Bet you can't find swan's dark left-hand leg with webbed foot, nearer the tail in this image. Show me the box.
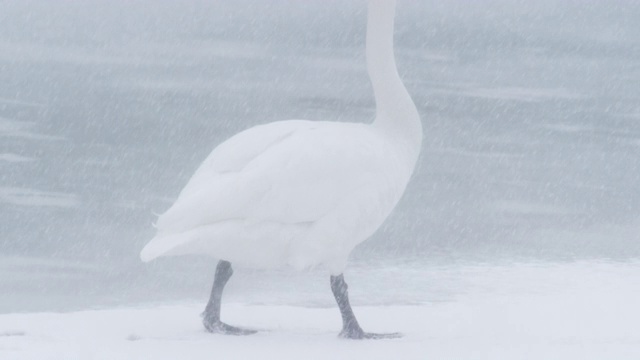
[202,260,257,335]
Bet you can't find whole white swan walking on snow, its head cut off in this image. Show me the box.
[140,0,422,339]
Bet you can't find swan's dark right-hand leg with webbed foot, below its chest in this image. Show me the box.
[331,274,402,339]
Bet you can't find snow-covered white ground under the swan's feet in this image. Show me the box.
[0,262,640,360]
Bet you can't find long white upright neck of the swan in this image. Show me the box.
[367,0,422,165]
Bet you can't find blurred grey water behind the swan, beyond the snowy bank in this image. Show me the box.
[0,0,640,312]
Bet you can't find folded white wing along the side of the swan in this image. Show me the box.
[157,121,394,233]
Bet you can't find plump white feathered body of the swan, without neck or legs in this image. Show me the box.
[142,121,411,274]
